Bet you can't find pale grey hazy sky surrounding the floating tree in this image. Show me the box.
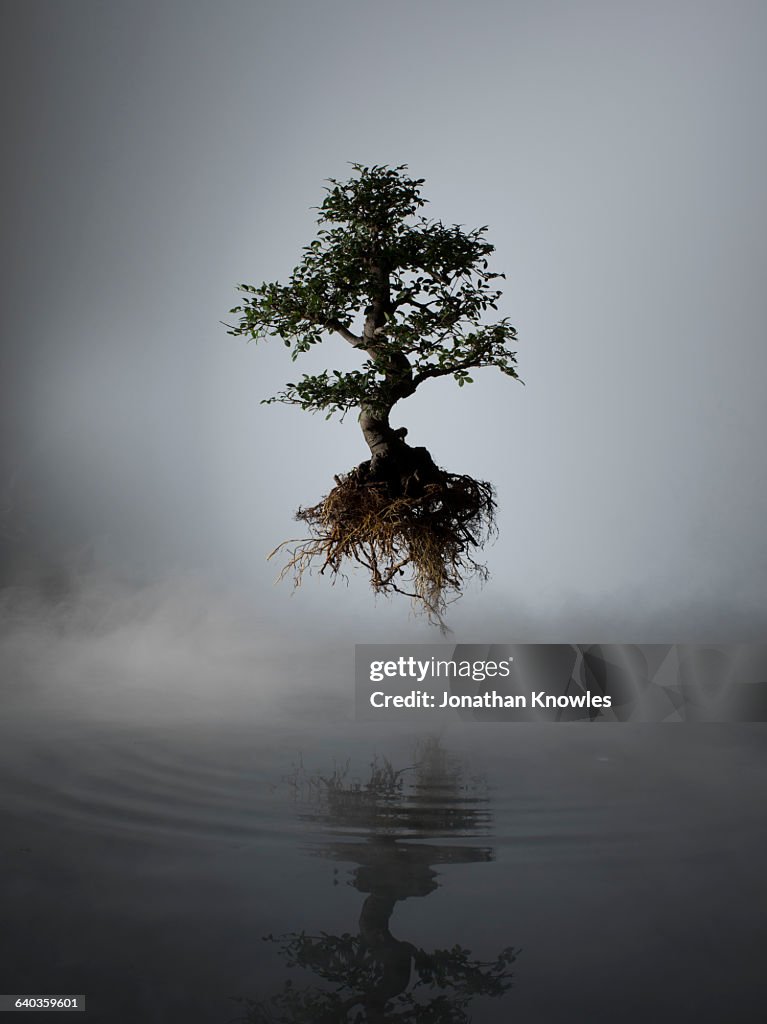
[0,0,767,641]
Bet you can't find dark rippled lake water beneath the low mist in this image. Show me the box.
[0,614,767,1024]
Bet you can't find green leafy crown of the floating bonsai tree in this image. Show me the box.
[224,164,517,415]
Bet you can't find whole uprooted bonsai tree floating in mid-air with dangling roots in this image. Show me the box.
[226,164,517,625]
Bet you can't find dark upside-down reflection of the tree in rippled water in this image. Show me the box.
[230,739,516,1024]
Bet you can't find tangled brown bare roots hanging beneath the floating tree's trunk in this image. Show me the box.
[269,470,496,630]
